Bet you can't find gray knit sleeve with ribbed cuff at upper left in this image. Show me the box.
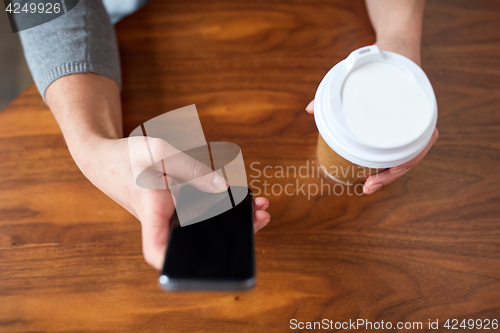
[19,0,121,100]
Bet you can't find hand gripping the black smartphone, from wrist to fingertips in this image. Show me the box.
[77,137,271,270]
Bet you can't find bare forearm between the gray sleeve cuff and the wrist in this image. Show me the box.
[46,74,123,173]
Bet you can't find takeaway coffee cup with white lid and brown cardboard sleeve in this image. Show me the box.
[314,45,437,184]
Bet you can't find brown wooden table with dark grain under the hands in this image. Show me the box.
[0,0,500,333]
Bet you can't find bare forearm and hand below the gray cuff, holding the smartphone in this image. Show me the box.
[45,73,271,269]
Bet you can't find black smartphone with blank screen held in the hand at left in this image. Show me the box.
[159,185,255,291]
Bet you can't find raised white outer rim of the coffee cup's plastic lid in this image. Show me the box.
[314,45,437,168]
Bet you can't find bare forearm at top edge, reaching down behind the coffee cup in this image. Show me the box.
[366,0,425,65]
